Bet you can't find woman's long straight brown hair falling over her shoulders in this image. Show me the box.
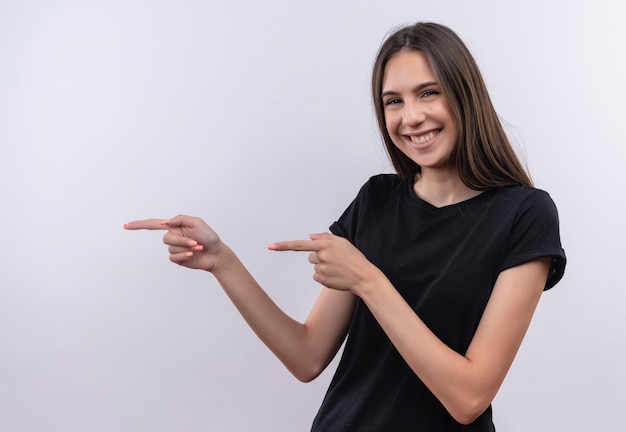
[372,23,533,190]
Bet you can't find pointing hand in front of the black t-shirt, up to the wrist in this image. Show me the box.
[268,233,382,295]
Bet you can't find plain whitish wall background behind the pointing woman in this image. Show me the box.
[0,0,626,432]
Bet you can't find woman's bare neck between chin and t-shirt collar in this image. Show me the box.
[413,170,480,207]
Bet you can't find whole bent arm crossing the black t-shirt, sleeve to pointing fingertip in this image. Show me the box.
[270,233,550,424]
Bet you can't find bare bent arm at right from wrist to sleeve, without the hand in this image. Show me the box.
[359,262,547,423]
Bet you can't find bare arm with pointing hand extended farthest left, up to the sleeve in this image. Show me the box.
[124,216,355,381]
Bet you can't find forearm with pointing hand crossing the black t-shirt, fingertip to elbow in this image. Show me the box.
[271,234,488,402]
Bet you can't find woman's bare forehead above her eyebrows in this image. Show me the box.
[382,49,437,91]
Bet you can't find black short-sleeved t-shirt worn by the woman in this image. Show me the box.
[312,174,565,432]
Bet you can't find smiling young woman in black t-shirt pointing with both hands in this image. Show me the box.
[125,23,565,432]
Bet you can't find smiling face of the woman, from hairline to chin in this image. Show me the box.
[382,50,458,173]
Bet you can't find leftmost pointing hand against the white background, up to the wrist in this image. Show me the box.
[124,216,224,272]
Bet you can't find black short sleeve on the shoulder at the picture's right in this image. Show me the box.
[500,190,566,290]
